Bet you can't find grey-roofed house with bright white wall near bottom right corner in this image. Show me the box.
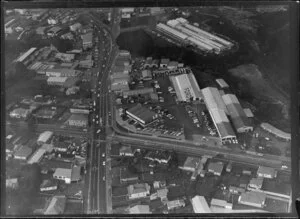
[238,191,266,208]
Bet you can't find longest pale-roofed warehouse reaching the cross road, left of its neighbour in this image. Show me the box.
[202,87,236,143]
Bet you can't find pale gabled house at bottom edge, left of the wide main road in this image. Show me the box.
[44,195,67,215]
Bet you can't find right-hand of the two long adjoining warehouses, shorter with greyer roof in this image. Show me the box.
[222,94,253,133]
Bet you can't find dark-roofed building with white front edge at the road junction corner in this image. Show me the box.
[126,104,157,126]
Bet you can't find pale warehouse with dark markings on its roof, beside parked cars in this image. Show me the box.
[170,73,202,101]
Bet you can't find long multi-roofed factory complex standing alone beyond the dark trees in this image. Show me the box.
[156,18,233,54]
